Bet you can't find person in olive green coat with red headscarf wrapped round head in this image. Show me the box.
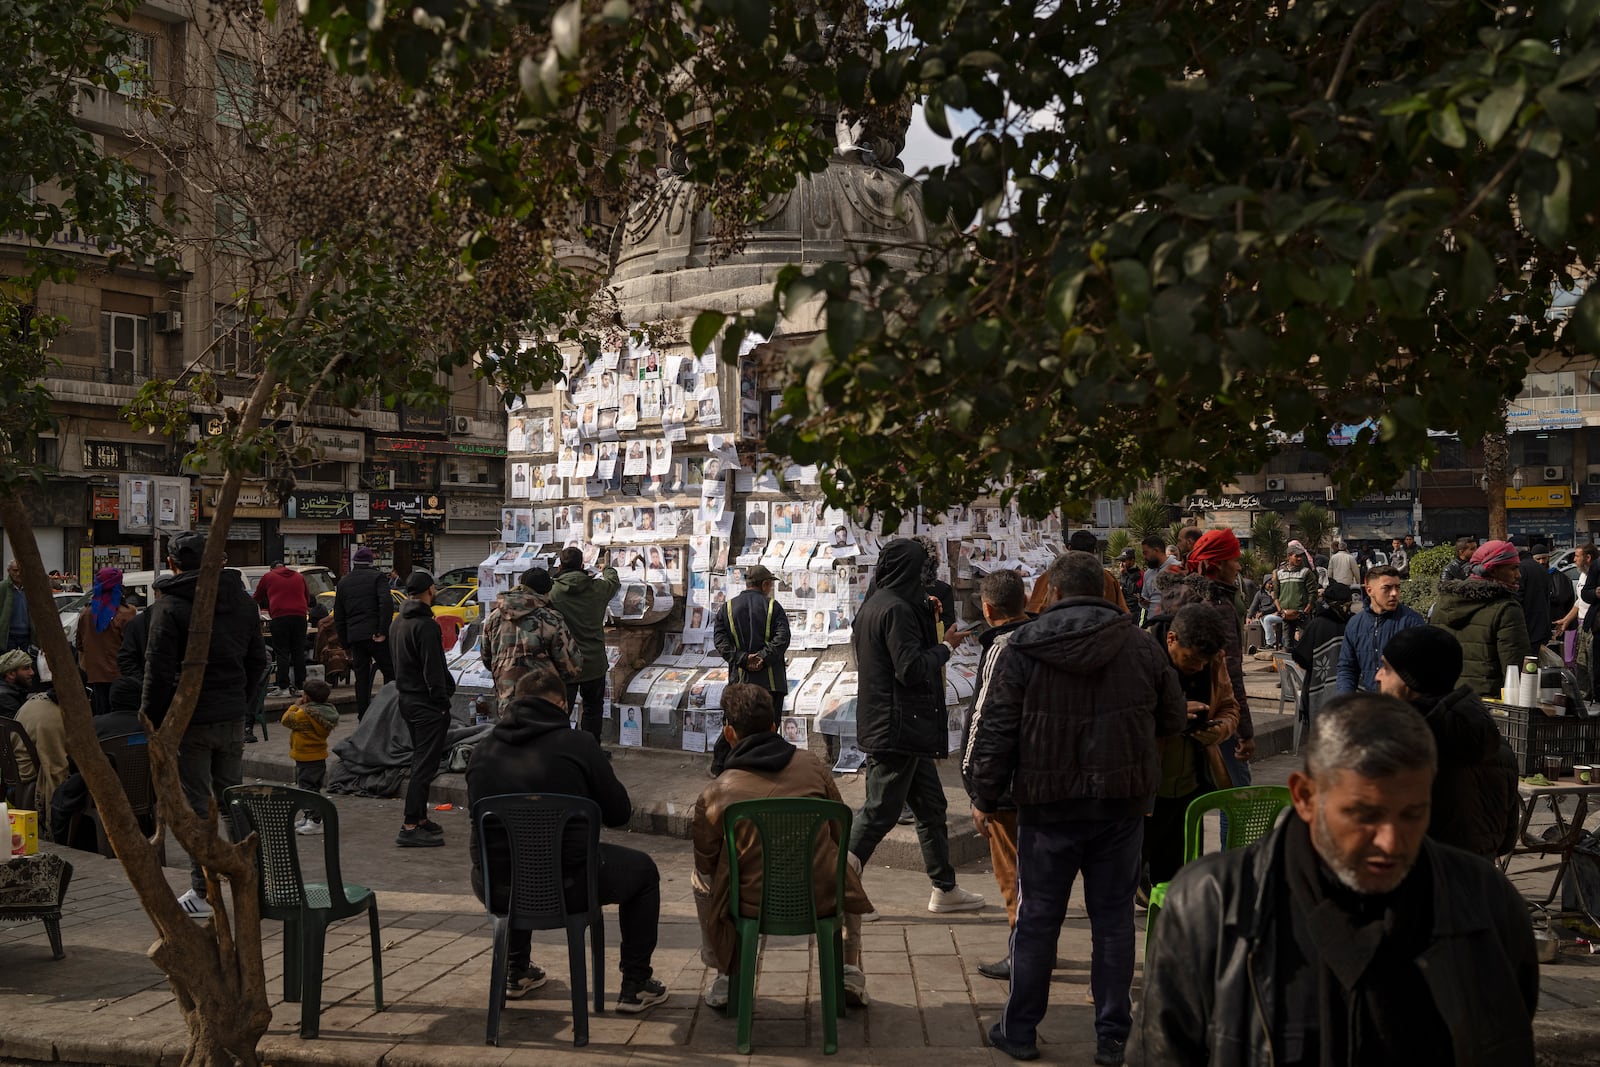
[1434,541,1533,699]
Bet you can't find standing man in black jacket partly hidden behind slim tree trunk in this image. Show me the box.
[144,533,267,918]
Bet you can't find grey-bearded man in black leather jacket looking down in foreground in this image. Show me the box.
[1131,693,1539,1067]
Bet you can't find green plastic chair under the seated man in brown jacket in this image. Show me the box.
[723,797,850,1056]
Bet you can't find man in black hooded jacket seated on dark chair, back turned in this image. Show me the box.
[467,664,667,1013]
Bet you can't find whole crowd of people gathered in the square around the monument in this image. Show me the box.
[0,528,1555,1065]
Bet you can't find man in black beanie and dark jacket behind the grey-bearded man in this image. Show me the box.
[1378,625,1517,859]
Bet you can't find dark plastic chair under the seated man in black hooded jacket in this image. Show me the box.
[472,793,605,1048]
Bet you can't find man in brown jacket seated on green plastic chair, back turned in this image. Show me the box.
[693,683,872,1008]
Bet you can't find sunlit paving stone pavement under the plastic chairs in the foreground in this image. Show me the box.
[9,757,1600,1067]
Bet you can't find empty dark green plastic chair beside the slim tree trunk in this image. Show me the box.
[222,785,384,1038]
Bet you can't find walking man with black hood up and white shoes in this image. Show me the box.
[850,537,984,912]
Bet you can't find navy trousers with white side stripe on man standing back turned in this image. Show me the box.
[1000,816,1144,1045]
